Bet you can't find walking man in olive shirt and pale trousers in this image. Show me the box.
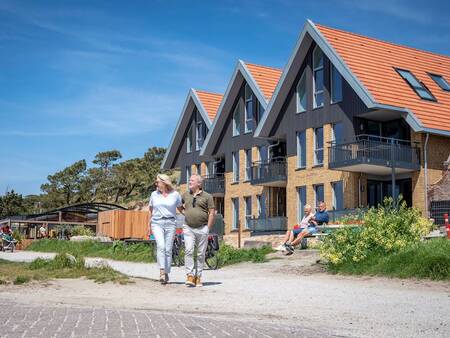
[182,175,215,286]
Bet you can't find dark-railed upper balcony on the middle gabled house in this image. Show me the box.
[250,157,287,187]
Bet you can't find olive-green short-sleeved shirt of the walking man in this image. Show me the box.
[182,190,215,228]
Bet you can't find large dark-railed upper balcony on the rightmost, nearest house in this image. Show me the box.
[328,135,420,175]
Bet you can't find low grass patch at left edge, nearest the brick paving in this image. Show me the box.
[0,254,129,285]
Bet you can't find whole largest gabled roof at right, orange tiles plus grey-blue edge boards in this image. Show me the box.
[255,20,450,136]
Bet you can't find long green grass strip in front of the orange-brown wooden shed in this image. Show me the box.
[27,239,155,263]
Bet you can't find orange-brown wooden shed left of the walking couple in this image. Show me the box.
[97,209,149,239]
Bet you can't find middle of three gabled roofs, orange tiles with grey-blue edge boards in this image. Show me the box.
[200,60,282,156]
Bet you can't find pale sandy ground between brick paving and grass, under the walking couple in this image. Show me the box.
[0,251,450,337]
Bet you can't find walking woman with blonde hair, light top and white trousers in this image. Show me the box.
[149,174,182,284]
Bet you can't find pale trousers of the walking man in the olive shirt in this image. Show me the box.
[183,224,209,277]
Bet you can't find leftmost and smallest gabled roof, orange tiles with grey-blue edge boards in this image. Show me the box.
[161,88,222,169]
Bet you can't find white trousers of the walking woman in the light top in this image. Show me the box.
[152,219,176,273]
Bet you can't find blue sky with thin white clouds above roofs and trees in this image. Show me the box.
[0,0,450,195]
